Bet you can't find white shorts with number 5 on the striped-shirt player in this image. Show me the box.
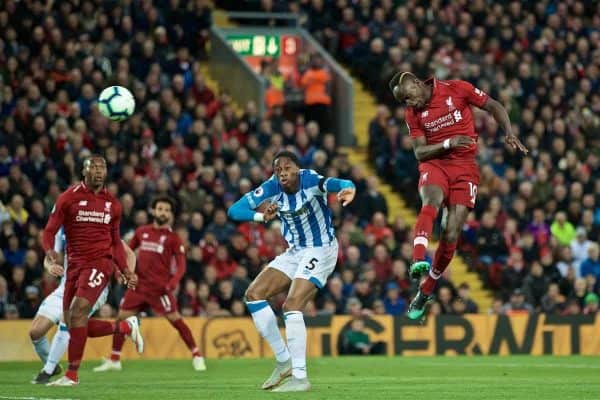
[269,240,338,289]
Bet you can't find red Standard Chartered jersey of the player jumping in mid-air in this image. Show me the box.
[405,78,488,162]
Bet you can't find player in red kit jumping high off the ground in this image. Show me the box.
[389,72,527,319]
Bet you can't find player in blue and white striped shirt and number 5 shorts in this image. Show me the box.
[228,151,356,392]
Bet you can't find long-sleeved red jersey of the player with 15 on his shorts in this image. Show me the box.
[42,183,127,271]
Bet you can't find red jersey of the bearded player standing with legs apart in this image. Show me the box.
[129,224,185,294]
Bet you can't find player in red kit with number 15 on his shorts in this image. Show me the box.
[42,155,144,386]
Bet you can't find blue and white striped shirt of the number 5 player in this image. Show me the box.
[245,169,336,248]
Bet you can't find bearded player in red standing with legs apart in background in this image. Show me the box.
[94,197,206,372]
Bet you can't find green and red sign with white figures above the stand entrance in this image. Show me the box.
[227,34,302,79]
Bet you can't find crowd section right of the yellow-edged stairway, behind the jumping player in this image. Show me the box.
[296,0,600,314]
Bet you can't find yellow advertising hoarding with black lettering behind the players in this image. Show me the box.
[0,315,600,361]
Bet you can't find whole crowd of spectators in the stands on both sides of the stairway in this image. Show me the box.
[0,0,600,318]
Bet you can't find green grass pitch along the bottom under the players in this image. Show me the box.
[0,356,600,400]
